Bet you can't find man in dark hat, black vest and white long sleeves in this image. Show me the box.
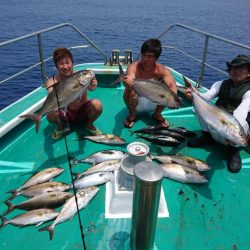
[186,55,250,173]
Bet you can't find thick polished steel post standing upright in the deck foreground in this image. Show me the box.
[130,161,163,250]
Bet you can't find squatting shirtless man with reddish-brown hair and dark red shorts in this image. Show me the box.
[46,48,102,139]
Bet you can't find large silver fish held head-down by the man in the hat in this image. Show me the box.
[184,77,248,147]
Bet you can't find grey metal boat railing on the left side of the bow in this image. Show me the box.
[0,23,108,85]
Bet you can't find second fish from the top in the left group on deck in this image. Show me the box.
[8,181,70,200]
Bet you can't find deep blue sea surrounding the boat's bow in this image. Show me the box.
[0,0,250,110]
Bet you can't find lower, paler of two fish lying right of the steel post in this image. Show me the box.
[160,163,208,184]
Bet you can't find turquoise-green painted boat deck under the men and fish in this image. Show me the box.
[0,65,250,250]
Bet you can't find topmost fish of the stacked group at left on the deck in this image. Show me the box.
[9,168,64,197]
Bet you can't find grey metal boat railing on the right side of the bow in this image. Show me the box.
[157,23,250,87]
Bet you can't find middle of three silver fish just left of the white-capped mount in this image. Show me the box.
[76,159,121,178]
